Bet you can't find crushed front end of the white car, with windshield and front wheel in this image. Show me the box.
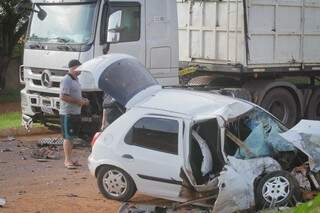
[215,106,320,212]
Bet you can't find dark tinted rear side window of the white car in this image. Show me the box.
[125,117,179,155]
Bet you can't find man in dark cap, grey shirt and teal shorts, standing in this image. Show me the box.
[60,59,89,169]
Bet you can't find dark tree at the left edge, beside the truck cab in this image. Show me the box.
[0,0,28,90]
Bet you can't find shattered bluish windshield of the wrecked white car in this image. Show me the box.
[224,107,295,159]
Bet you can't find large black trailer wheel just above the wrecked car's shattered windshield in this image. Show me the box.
[261,88,298,127]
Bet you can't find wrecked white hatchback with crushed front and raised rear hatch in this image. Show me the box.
[79,54,320,212]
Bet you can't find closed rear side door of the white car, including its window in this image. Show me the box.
[119,116,183,198]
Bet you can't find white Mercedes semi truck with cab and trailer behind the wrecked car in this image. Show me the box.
[20,0,320,136]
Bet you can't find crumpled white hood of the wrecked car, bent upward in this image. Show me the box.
[279,120,320,172]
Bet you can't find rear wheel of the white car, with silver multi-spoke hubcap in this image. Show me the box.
[97,166,137,201]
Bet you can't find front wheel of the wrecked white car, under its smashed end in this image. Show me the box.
[256,171,301,209]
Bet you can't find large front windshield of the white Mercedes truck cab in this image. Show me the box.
[28,3,96,44]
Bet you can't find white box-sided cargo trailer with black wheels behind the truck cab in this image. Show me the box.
[177,0,320,127]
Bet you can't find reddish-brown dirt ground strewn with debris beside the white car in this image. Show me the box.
[0,135,164,213]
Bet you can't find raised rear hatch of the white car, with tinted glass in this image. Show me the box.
[78,54,161,108]
